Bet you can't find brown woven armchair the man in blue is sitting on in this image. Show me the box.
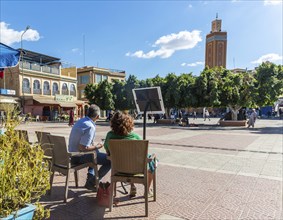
[47,135,99,202]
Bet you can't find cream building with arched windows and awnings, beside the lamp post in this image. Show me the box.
[0,50,84,120]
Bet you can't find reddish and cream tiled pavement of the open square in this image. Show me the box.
[16,119,283,220]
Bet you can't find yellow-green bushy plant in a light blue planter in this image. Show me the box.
[0,105,50,220]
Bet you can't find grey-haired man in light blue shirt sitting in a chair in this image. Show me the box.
[68,105,111,191]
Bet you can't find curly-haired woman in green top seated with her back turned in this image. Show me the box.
[104,112,157,197]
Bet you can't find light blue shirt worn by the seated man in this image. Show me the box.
[68,117,95,152]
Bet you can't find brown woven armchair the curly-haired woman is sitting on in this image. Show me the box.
[109,140,156,217]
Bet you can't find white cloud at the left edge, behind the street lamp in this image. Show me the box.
[0,21,40,46]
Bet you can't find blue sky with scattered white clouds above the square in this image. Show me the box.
[0,0,283,79]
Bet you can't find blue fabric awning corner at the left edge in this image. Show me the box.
[0,43,20,68]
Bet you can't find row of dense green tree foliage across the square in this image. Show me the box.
[85,62,283,113]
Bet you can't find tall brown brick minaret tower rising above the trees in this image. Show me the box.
[205,16,227,68]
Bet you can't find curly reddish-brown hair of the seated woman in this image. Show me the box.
[111,112,134,136]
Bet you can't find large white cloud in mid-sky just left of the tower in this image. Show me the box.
[126,30,202,59]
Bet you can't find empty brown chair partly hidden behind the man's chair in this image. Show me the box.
[35,131,52,169]
